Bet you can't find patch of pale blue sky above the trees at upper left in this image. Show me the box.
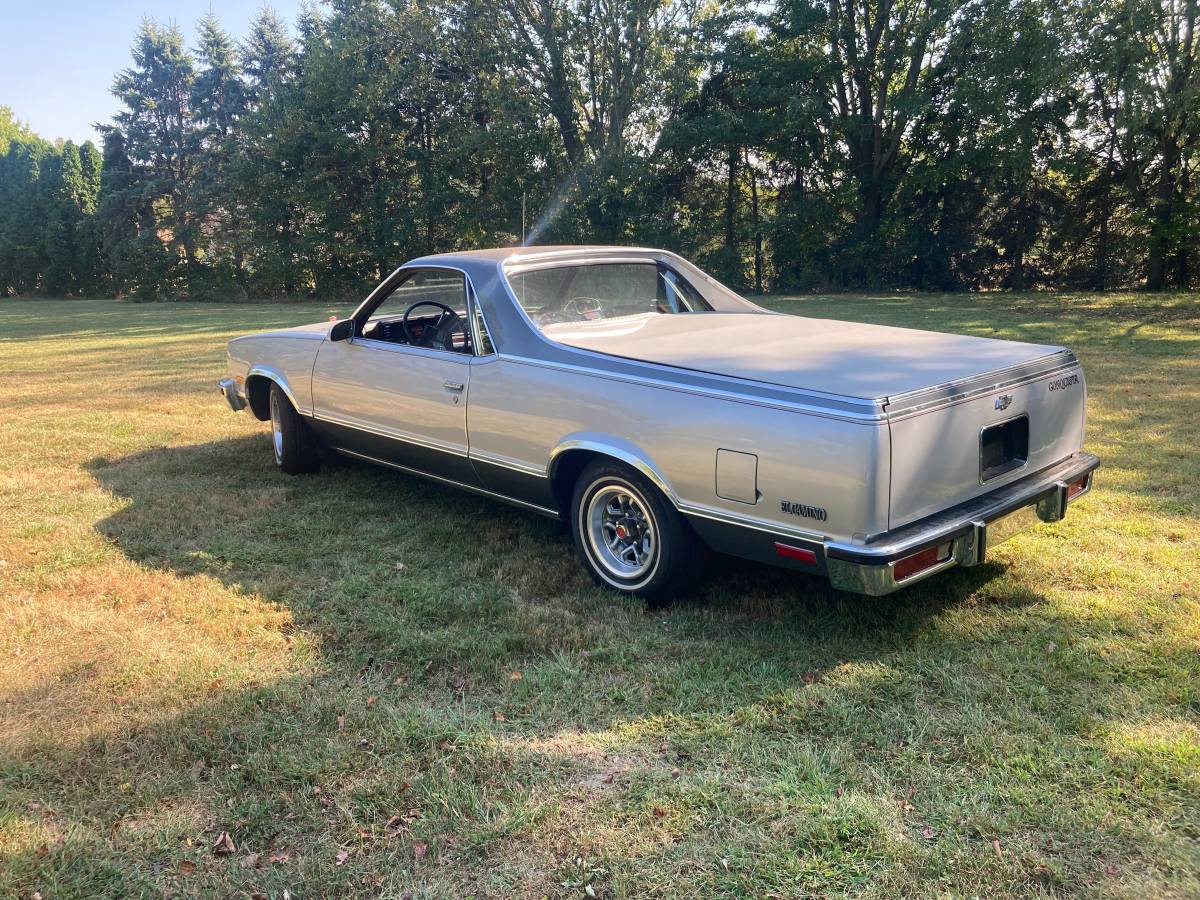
[0,0,309,143]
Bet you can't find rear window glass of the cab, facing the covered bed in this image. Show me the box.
[509,260,712,328]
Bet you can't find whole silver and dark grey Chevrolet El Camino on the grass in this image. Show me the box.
[220,247,1099,602]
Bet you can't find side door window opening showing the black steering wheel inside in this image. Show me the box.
[355,269,475,355]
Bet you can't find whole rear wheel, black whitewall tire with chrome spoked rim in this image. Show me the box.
[571,460,703,606]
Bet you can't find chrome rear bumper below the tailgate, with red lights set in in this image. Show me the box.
[824,451,1100,595]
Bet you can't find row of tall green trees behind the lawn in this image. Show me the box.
[0,0,1200,298]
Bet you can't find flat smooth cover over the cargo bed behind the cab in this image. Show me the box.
[542,312,1062,400]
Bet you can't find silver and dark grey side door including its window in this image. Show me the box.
[312,269,479,485]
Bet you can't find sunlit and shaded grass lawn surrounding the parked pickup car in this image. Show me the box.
[0,294,1200,900]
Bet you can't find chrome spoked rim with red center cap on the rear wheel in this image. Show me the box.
[583,484,659,581]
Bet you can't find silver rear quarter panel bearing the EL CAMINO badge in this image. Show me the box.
[467,358,888,540]
